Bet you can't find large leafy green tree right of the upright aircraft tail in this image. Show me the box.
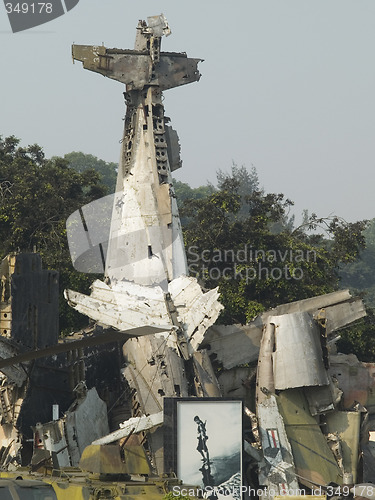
[181,167,366,324]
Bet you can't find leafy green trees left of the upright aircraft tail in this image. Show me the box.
[0,136,107,331]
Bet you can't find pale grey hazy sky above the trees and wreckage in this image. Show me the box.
[0,0,375,222]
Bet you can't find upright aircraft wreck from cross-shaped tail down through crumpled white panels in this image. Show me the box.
[66,15,223,473]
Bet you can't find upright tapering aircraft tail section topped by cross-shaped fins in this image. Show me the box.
[73,15,200,290]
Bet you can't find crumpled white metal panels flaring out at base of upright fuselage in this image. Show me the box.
[65,276,223,353]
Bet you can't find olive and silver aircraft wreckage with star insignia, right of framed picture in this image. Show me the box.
[256,292,369,494]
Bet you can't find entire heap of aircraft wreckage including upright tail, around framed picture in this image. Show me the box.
[0,15,375,496]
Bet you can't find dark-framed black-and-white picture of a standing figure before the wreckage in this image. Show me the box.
[164,398,243,500]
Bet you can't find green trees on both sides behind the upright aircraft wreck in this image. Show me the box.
[0,136,375,357]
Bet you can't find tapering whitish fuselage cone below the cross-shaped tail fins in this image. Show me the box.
[105,87,187,289]
